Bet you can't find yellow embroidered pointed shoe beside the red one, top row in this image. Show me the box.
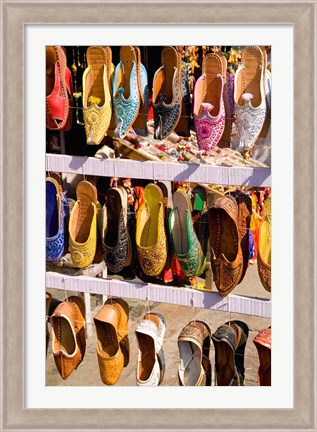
[83,46,112,144]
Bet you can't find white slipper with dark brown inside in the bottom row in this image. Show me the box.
[135,312,166,387]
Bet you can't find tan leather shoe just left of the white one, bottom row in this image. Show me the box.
[94,298,130,385]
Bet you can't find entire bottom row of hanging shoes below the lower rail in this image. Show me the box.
[46,293,271,386]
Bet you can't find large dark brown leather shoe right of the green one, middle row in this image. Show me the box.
[208,196,243,296]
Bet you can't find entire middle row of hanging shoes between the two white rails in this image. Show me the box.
[46,173,271,296]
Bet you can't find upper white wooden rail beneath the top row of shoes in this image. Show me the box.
[46,154,271,187]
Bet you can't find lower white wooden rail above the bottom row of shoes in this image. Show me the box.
[46,272,271,318]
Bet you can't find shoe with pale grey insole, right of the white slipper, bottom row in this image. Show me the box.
[177,321,211,386]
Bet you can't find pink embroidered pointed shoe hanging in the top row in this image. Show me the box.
[194,54,226,152]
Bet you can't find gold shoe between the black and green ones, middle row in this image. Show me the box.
[136,183,167,276]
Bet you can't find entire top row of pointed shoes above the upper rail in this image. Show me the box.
[46,46,271,153]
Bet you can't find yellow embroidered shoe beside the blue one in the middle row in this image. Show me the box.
[69,180,101,268]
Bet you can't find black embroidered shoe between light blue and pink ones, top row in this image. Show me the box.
[152,46,191,139]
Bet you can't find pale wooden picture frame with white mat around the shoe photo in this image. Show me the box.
[1,1,316,431]
